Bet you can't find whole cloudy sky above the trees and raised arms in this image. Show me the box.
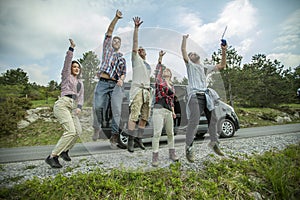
[0,0,300,85]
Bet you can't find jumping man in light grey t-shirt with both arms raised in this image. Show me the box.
[181,35,227,162]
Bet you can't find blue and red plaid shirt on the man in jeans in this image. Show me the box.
[98,35,126,80]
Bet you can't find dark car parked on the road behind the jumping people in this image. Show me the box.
[98,83,239,146]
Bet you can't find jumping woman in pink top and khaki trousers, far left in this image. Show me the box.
[45,39,84,168]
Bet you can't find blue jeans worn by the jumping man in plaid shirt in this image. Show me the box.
[93,80,124,134]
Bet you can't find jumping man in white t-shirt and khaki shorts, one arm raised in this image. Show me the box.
[127,17,152,152]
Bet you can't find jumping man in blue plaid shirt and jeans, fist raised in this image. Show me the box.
[92,10,126,149]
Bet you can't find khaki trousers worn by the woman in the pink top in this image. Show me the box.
[52,97,82,155]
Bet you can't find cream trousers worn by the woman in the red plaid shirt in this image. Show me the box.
[152,108,174,152]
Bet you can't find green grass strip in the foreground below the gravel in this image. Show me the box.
[0,144,300,200]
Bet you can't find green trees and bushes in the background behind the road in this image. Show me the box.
[0,46,300,135]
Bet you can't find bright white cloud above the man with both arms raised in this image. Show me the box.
[177,0,257,56]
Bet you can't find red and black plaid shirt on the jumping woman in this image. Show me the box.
[155,63,175,110]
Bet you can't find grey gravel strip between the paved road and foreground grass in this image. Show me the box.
[0,133,300,187]
